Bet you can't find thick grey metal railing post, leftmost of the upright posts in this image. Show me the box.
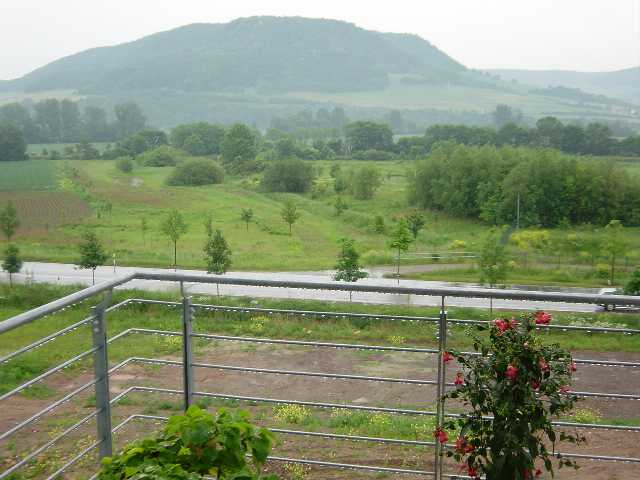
[91,302,113,458]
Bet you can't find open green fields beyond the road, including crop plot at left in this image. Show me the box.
[0,153,638,286]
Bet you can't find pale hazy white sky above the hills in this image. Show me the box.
[0,0,640,79]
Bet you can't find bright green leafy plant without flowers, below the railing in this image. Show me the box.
[98,405,277,480]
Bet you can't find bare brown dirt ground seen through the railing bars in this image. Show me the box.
[0,342,640,480]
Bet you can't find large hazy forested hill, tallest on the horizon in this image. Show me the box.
[0,17,468,94]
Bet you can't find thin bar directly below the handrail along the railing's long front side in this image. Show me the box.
[131,298,640,334]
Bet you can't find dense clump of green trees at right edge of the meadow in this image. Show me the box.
[409,142,640,227]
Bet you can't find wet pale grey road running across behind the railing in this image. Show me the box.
[0,262,600,312]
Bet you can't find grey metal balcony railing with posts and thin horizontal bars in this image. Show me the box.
[0,273,640,480]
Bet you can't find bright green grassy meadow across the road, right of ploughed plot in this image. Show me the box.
[11,161,496,270]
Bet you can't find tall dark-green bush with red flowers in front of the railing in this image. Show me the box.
[434,312,584,480]
